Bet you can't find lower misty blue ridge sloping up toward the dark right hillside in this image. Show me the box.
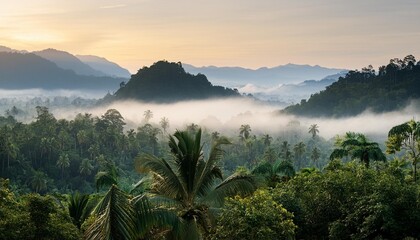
[238,71,347,104]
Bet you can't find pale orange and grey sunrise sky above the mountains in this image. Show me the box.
[0,0,420,73]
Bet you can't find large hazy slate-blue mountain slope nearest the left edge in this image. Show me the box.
[0,52,125,91]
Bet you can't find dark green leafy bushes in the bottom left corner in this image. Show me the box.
[0,179,80,240]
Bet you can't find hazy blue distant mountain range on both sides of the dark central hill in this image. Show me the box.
[0,46,346,103]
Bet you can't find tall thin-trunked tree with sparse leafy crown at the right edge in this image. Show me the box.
[386,119,420,181]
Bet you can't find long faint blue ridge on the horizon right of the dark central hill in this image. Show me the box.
[184,64,346,87]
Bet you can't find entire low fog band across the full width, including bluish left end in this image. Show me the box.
[0,89,420,142]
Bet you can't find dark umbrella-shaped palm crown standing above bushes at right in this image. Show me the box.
[330,132,386,167]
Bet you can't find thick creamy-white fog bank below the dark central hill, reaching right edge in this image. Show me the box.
[54,99,420,142]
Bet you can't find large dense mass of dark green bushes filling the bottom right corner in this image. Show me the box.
[273,161,420,239]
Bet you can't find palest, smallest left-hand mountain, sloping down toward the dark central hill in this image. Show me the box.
[76,55,131,79]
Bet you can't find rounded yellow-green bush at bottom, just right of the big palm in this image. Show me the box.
[212,190,297,240]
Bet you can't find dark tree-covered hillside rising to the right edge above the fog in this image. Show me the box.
[283,55,420,117]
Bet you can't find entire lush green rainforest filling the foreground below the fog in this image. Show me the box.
[0,106,420,239]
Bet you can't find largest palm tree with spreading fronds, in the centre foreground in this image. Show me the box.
[136,129,256,239]
